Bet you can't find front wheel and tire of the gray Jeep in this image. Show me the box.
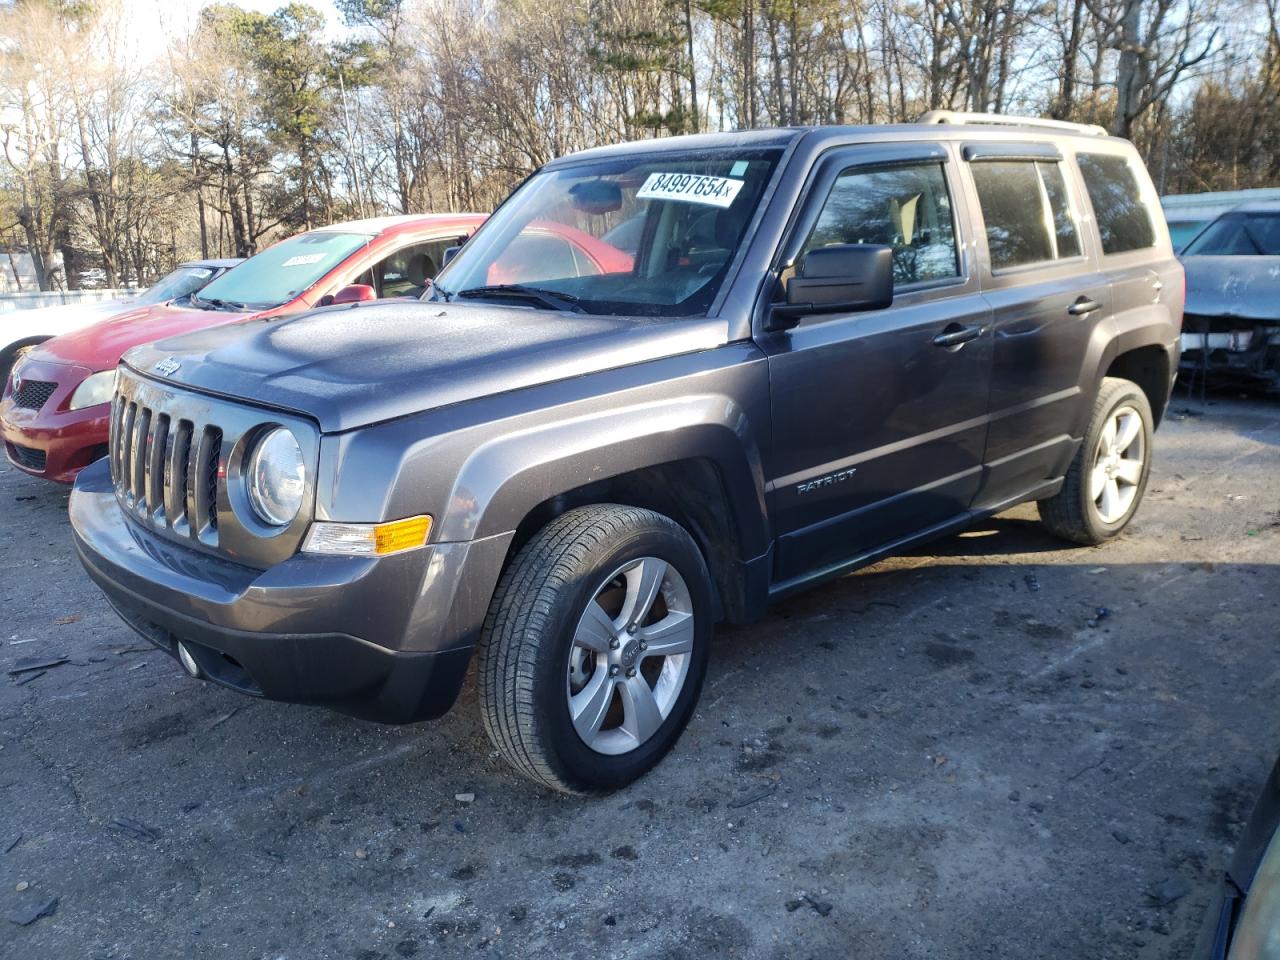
[476,504,713,794]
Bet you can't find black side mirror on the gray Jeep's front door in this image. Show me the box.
[768,243,893,330]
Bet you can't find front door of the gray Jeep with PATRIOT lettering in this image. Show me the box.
[758,143,991,581]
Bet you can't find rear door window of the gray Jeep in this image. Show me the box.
[970,160,1080,270]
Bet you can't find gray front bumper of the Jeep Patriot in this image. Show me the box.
[69,462,483,723]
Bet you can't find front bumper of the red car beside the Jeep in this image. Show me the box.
[0,360,111,484]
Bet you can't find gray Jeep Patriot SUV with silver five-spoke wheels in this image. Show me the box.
[70,114,1183,792]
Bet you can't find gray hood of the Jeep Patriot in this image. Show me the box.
[125,301,726,433]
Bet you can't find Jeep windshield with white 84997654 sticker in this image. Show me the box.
[431,150,781,316]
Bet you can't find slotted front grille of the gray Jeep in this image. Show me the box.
[109,394,223,547]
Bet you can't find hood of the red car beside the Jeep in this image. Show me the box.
[33,303,257,371]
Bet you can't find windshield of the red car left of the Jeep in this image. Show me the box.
[195,230,371,310]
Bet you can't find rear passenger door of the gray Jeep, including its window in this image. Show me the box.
[964,142,1110,509]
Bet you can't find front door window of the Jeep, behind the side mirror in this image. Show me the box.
[801,163,960,287]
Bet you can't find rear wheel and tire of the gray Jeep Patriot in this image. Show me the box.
[1037,376,1155,545]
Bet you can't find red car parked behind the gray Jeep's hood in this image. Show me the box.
[0,214,485,484]
